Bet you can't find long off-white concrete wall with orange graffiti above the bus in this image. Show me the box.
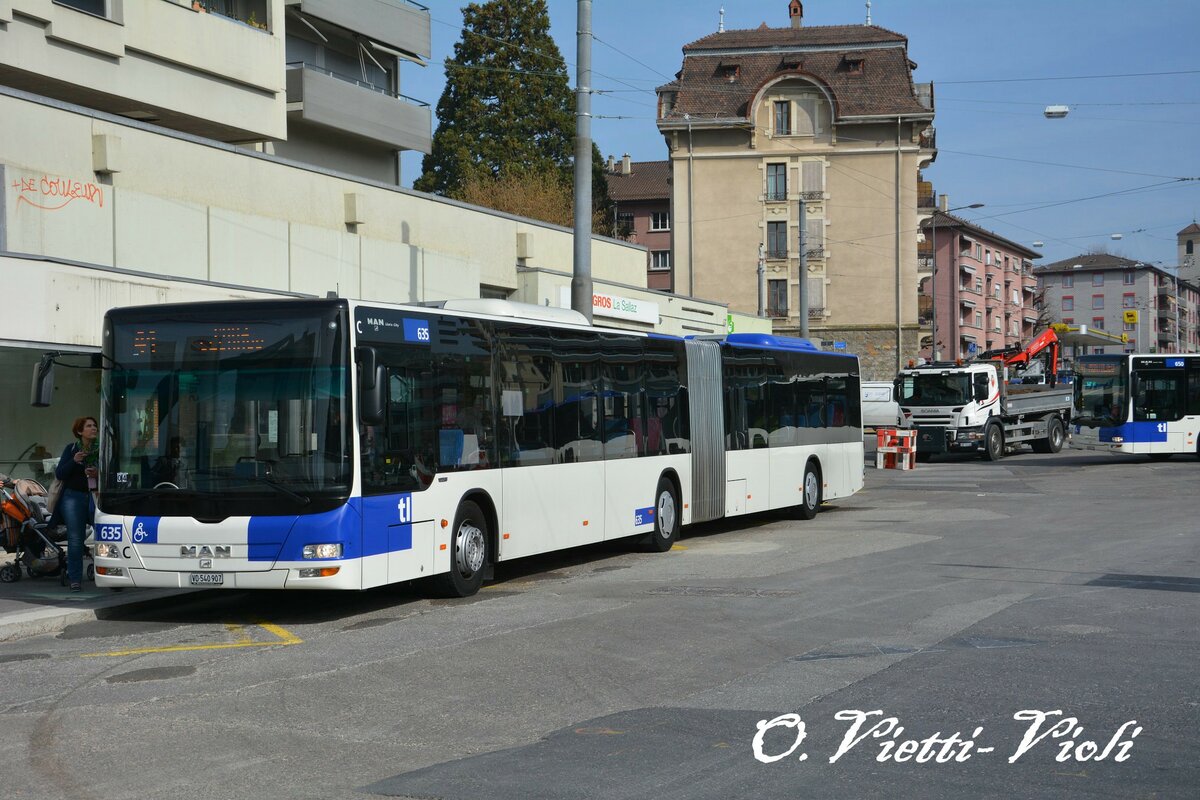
[0,95,646,302]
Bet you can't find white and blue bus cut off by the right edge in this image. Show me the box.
[1072,354,1200,459]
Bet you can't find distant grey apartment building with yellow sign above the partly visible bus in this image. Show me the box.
[1033,253,1200,353]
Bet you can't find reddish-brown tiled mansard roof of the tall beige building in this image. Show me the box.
[664,25,932,119]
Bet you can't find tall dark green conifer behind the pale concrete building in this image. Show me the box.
[413,0,575,197]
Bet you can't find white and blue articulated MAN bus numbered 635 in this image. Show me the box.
[95,299,863,596]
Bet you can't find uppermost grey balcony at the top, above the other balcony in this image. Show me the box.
[283,0,432,60]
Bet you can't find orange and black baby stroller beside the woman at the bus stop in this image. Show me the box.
[0,475,95,585]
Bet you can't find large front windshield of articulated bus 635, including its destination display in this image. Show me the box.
[101,303,353,519]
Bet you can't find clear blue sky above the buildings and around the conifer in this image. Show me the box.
[402,0,1200,269]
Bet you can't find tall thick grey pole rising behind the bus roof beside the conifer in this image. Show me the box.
[571,0,593,323]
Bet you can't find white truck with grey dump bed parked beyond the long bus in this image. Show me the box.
[895,359,1072,461]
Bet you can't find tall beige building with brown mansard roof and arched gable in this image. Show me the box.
[658,0,936,378]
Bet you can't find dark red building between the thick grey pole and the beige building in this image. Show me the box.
[607,155,673,291]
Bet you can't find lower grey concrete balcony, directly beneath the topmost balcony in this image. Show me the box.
[287,62,432,152]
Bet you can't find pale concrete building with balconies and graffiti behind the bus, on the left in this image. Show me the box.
[0,0,755,475]
